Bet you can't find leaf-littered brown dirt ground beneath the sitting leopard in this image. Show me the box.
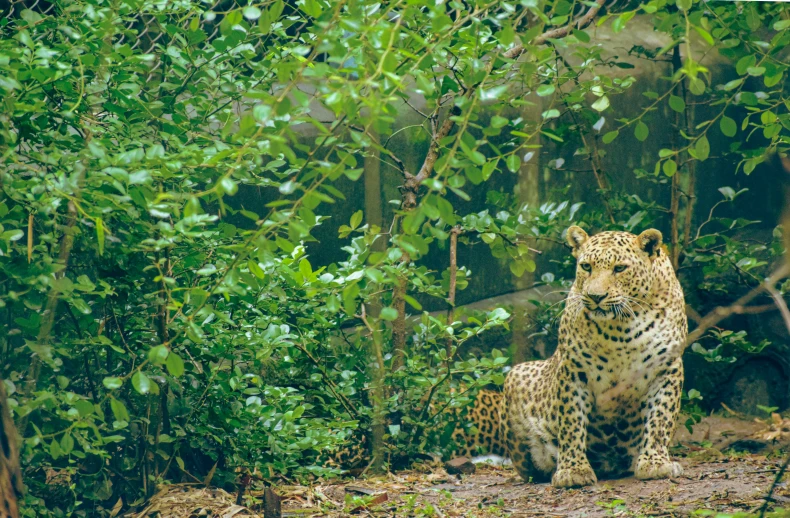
[136,416,790,518]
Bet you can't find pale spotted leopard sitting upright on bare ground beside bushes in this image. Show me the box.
[500,226,688,488]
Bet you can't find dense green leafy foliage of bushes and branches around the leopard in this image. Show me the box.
[0,0,790,516]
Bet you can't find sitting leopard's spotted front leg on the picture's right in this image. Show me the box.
[634,358,683,480]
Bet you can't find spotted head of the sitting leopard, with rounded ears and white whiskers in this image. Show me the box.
[567,226,664,320]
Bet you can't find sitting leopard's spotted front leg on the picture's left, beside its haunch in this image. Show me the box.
[551,368,598,487]
